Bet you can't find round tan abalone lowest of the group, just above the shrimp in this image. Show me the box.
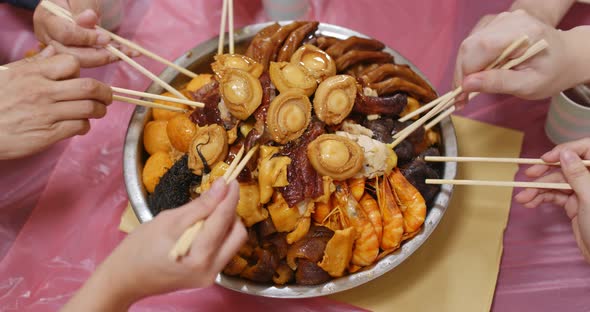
[307,134,364,181]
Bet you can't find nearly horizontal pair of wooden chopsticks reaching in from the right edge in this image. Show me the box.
[424,156,590,190]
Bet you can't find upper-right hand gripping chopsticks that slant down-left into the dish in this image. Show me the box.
[454,10,583,105]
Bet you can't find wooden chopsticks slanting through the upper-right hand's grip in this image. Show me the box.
[390,35,548,147]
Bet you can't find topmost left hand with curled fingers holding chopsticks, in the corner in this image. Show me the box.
[33,0,137,67]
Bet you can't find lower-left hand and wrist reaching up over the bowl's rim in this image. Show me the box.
[66,179,247,311]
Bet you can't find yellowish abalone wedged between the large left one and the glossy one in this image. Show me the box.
[269,62,318,96]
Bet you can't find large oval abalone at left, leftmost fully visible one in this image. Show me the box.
[220,68,262,120]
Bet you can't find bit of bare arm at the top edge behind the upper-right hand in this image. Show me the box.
[510,0,576,27]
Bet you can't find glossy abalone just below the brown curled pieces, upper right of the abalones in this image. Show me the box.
[291,44,336,81]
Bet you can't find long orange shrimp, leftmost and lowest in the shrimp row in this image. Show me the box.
[334,183,379,266]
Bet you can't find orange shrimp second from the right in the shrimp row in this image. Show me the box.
[376,178,404,251]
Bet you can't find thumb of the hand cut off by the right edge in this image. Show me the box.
[560,150,590,203]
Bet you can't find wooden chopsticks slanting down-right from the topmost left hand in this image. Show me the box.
[39,0,191,100]
